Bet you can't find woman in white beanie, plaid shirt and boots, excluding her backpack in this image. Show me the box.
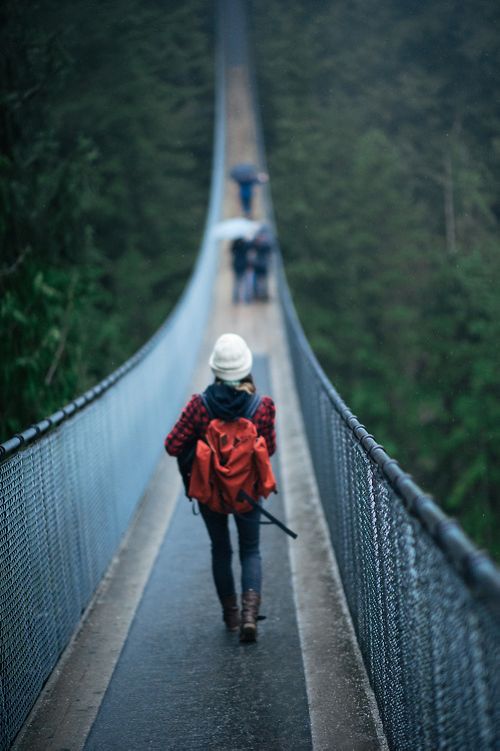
[165,334,276,641]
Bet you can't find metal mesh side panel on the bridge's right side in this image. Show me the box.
[280,260,500,751]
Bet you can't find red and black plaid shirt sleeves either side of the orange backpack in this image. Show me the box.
[165,394,276,456]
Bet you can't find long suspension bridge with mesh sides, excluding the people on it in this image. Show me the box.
[0,0,500,751]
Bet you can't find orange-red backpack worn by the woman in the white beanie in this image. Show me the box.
[189,417,276,514]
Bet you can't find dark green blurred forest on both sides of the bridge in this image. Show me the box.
[0,0,500,558]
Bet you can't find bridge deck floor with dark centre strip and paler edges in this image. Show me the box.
[15,2,385,751]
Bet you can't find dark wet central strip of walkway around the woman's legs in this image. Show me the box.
[85,357,312,751]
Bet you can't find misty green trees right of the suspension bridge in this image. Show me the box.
[253,0,500,557]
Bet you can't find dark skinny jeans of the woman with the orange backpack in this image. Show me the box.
[199,503,262,600]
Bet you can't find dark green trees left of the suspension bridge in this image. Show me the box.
[0,0,213,440]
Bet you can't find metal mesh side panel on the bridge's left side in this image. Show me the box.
[0,36,224,749]
